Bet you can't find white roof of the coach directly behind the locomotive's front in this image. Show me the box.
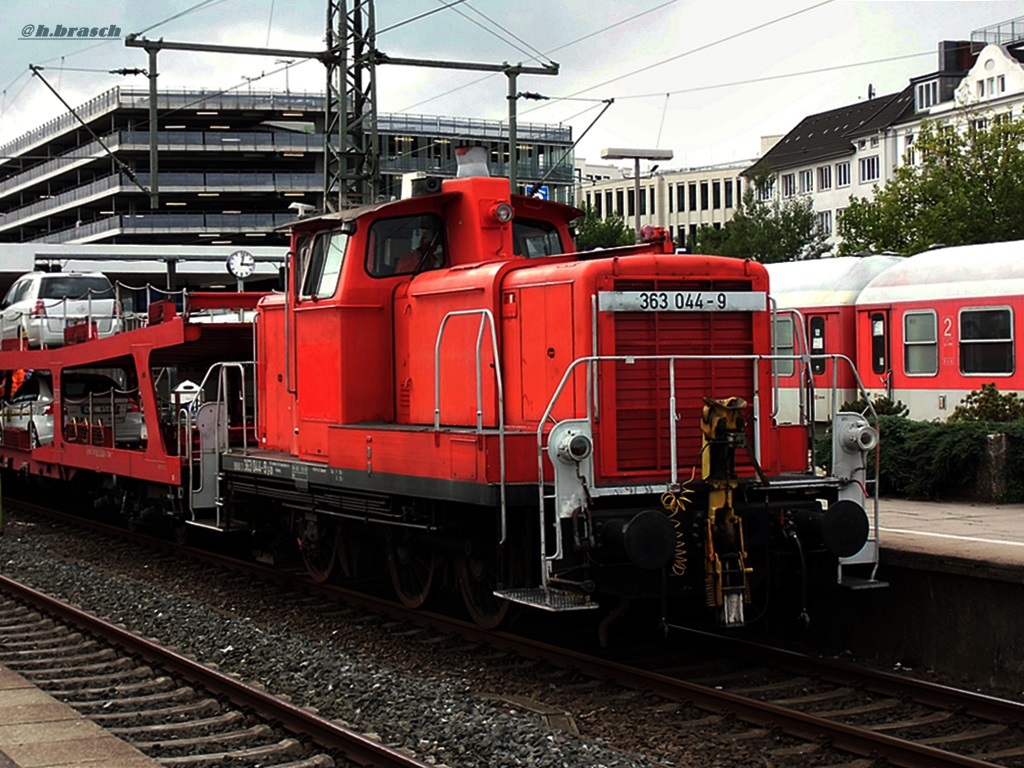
[765,256,904,309]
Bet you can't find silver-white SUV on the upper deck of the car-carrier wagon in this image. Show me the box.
[0,272,121,347]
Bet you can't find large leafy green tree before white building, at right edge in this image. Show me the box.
[839,110,1024,255]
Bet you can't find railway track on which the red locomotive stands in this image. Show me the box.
[2,505,1024,768]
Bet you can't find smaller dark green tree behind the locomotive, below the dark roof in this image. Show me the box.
[692,168,828,264]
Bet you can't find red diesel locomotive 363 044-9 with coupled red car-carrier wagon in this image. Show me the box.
[0,177,879,626]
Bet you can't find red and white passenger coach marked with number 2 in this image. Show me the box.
[856,241,1024,421]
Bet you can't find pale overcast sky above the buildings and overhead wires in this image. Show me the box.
[0,0,1024,168]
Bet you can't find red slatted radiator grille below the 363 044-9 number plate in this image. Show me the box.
[598,285,754,481]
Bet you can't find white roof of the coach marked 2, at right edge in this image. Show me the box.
[858,240,1024,304]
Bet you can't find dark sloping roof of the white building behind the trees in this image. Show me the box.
[743,86,913,173]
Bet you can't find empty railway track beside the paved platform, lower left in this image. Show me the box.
[0,577,425,768]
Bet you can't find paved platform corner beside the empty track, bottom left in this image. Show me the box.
[0,667,160,768]
